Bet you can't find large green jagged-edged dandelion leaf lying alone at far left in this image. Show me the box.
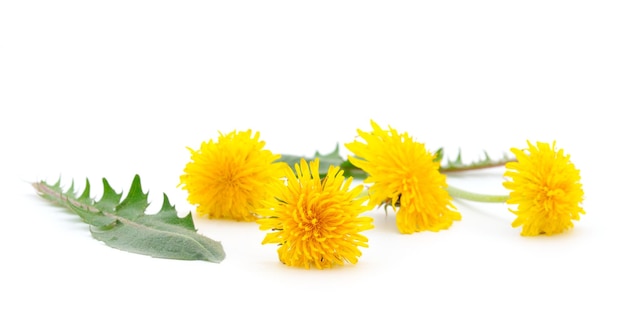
[33,175,225,262]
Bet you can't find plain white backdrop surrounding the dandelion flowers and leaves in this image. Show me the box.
[0,0,626,319]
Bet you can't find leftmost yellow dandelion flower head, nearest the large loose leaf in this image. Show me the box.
[180,130,284,221]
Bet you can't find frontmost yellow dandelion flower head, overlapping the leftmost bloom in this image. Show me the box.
[257,159,374,269]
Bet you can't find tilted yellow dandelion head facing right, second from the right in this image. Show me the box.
[346,121,461,233]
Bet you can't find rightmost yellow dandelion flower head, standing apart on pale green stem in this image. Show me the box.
[503,142,585,236]
